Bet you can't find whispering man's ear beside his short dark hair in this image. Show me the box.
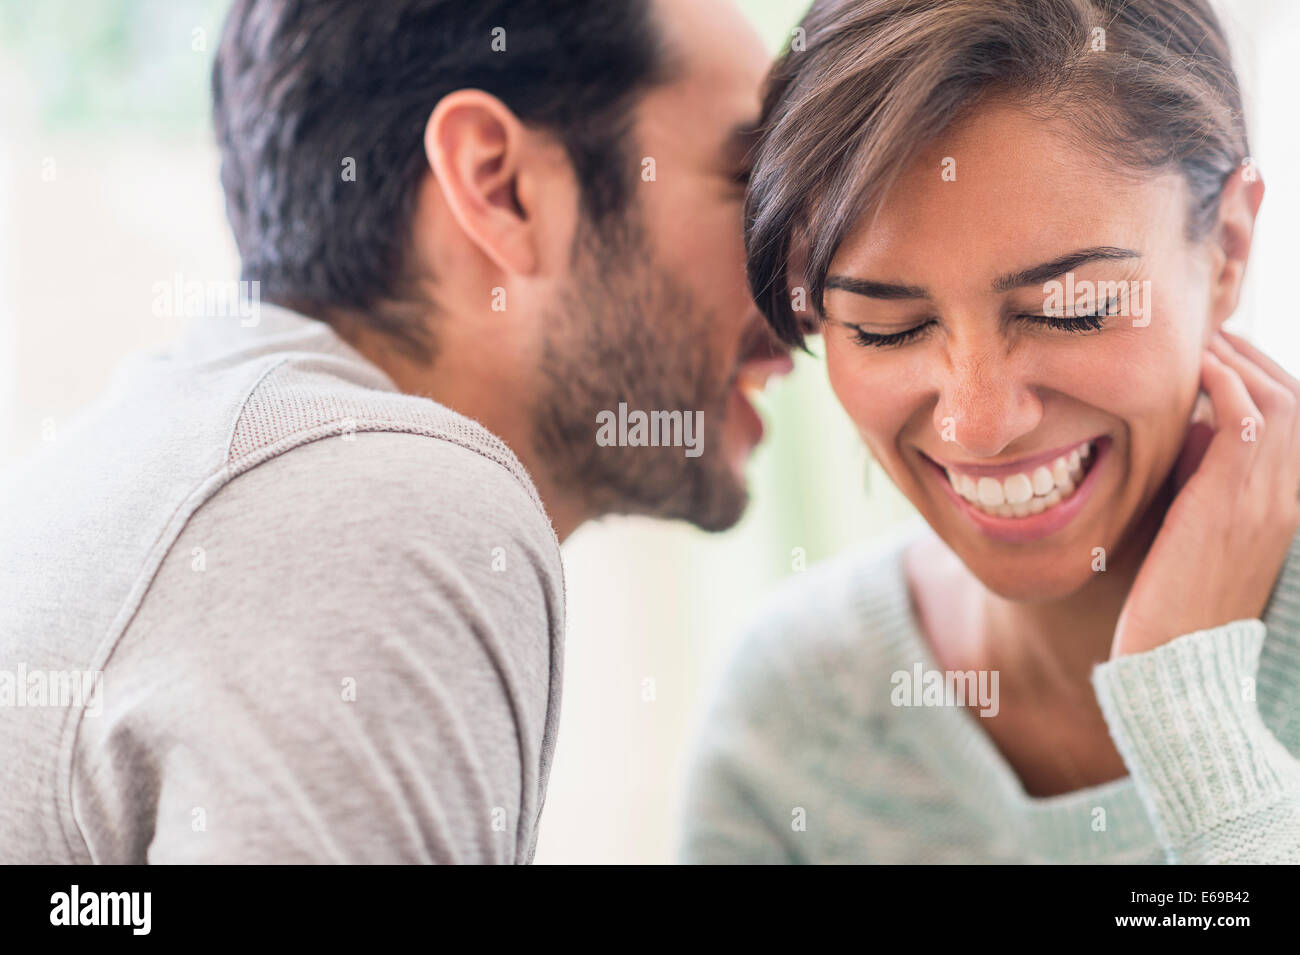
[424,90,538,275]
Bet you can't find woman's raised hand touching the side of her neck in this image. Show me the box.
[1110,333,1300,659]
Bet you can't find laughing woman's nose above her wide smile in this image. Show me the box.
[935,340,1043,457]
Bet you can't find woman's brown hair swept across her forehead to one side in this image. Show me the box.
[745,0,1249,344]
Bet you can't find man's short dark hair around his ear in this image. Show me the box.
[212,0,662,353]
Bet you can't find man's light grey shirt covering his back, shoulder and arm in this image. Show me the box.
[0,307,563,863]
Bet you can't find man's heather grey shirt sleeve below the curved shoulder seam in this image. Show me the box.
[77,431,563,861]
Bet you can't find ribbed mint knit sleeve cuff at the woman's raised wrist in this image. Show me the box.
[1092,620,1296,846]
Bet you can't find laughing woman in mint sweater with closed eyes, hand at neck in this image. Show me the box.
[684,0,1300,863]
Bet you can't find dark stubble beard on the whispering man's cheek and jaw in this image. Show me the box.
[533,220,749,531]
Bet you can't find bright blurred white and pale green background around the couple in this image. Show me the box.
[0,0,1300,863]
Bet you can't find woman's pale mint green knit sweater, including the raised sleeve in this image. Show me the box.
[681,528,1300,864]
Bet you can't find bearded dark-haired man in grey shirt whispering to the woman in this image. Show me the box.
[0,0,789,863]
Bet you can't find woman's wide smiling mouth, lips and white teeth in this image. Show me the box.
[930,437,1110,542]
